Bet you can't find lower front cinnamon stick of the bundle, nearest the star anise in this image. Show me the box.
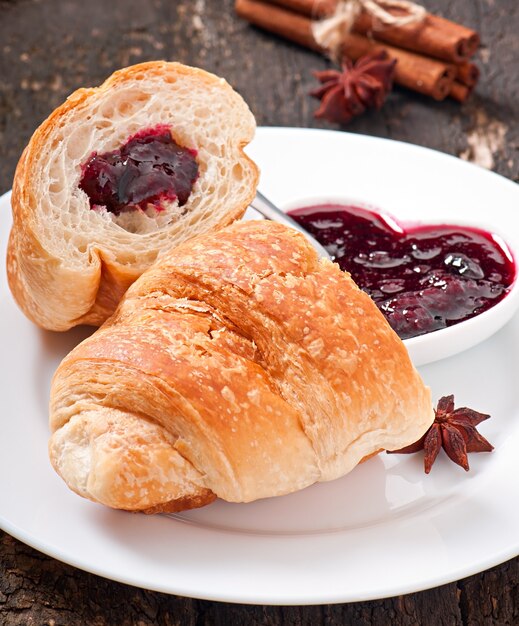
[236,0,455,100]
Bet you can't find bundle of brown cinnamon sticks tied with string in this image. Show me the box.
[236,0,479,102]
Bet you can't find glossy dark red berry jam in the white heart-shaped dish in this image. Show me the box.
[290,205,515,339]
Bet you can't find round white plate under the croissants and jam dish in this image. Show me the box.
[0,129,519,604]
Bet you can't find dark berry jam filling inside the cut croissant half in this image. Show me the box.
[79,124,198,215]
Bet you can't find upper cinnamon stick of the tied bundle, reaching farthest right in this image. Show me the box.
[267,0,479,63]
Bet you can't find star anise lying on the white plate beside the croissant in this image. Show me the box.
[391,396,494,474]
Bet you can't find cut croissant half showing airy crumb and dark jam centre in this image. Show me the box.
[7,61,258,330]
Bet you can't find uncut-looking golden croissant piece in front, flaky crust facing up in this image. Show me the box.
[49,221,433,512]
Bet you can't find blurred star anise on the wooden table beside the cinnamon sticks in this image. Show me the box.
[310,50,396,124]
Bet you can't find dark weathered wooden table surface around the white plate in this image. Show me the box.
[0,0,519,626]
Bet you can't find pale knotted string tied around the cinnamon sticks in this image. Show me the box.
[312,0,427,57]
